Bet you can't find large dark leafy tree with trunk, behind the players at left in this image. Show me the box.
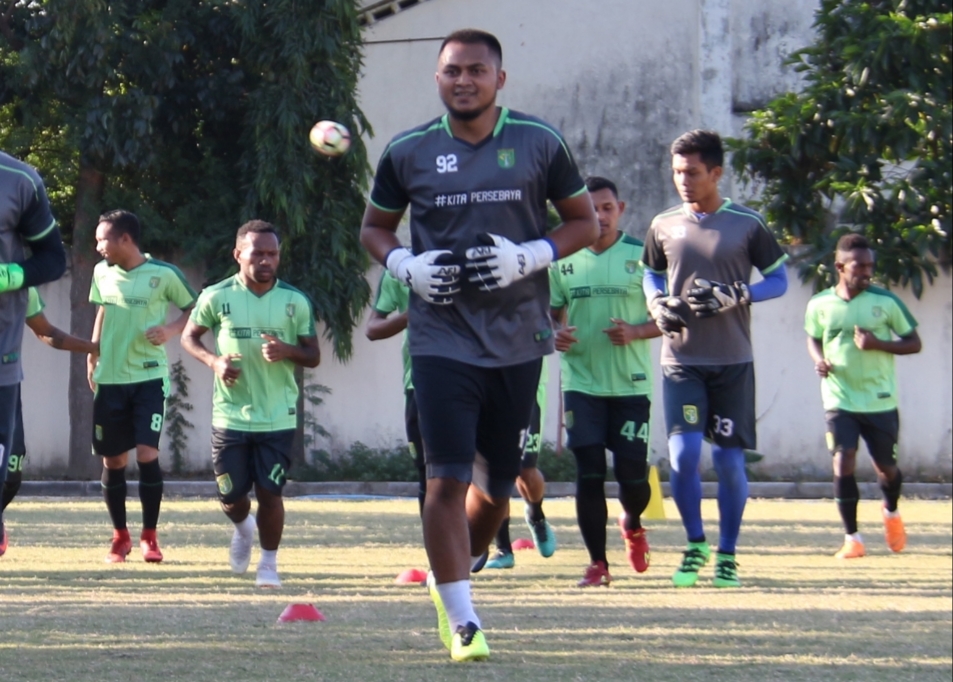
[0,0,369,475]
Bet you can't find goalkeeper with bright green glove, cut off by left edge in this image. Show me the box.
[0,151,66,552]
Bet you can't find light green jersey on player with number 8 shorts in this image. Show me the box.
[89,254,196,384]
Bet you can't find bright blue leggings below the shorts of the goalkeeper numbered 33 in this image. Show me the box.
[668,432,748,554]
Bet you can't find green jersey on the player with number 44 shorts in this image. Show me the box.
[549,235,652,397]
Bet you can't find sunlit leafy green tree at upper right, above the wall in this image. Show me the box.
[728,0,953,297]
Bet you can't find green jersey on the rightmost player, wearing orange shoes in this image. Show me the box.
[804,287,917,412]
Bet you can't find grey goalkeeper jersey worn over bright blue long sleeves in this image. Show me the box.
[642,199,788,365]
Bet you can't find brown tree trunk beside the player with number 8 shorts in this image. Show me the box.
[68,161,106,480]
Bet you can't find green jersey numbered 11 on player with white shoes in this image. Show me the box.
[191,275,315,432]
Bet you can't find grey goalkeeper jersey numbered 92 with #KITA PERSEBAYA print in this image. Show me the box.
[371,108,586,367]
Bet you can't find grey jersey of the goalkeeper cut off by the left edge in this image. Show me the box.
[0,152,56,386]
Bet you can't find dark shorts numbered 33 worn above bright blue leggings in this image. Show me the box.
[662,362,758,450]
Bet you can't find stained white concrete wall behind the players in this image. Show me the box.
[16,0,953,478]
